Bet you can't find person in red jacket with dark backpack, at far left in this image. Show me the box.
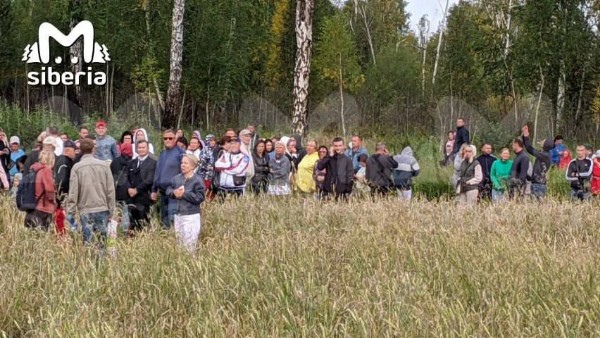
[25,150,56,231]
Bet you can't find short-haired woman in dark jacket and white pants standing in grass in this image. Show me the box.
[166,154,205,252]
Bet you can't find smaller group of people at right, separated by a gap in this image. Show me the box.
[441,118,600,205]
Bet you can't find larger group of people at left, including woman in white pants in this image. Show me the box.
[0,120,419,251]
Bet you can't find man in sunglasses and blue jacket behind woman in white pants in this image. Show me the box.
[150,129,185,229]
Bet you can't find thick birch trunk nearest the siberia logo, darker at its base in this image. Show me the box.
[162,0,185,128]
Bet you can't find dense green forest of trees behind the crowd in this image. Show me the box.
[0,0,600,143]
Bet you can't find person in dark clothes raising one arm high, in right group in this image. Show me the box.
[522,126,554,201]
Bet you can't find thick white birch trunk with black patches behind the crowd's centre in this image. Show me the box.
[292,0,315,136]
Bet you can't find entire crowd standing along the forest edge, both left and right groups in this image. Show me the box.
[0,119,600,251]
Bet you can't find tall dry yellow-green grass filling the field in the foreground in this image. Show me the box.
[0,198,600,337]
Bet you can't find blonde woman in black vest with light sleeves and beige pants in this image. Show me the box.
[456,145,483,205]
